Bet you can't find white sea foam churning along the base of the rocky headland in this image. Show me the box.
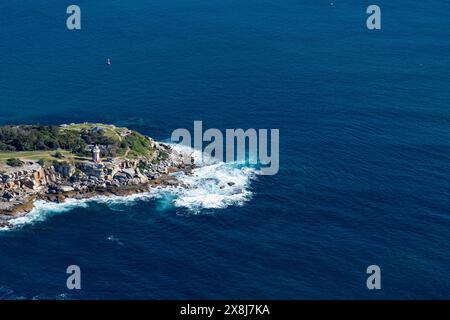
[0,145,258,231]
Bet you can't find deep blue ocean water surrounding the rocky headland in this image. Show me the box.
[0,0,450,299]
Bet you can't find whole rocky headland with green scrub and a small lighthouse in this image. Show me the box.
[0,123,194,227]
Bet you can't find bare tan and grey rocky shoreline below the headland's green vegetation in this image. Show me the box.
[0,142,195,228]
